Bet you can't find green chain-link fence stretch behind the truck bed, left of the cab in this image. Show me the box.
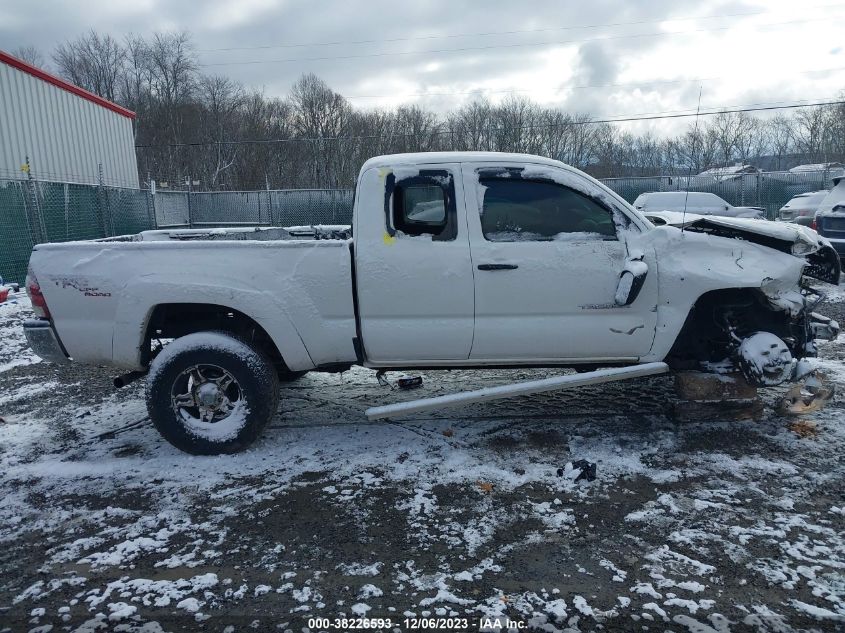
[0,179,353,283]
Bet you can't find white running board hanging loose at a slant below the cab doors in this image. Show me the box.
[366,363,669,420]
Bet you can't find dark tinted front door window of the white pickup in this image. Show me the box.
[479,174,617,242]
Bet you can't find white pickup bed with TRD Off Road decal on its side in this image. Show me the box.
[30,227,356,370]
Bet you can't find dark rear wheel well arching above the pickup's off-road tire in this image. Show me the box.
[141,303,288,371]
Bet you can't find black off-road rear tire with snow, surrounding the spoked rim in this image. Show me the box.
[146,332,279,455]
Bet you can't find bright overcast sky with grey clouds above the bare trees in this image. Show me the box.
[0,0,845,129]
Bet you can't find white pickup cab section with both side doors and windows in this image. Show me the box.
[354,153,658,367]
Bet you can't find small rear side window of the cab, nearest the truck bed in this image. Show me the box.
[384,169,457,240]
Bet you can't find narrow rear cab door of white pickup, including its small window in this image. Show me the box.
[354,163,474,366]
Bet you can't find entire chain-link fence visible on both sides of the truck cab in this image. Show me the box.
[0,171,838,282]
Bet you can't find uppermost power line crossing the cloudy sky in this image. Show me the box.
[197,4,841,53]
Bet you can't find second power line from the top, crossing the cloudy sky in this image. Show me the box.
[198,15,831,68]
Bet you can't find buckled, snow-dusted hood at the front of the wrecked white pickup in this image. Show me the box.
[643,211,841,285]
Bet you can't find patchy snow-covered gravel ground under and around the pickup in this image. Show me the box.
[0,291,845,633]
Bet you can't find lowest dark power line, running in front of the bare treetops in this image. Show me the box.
[135,100,845,149]
